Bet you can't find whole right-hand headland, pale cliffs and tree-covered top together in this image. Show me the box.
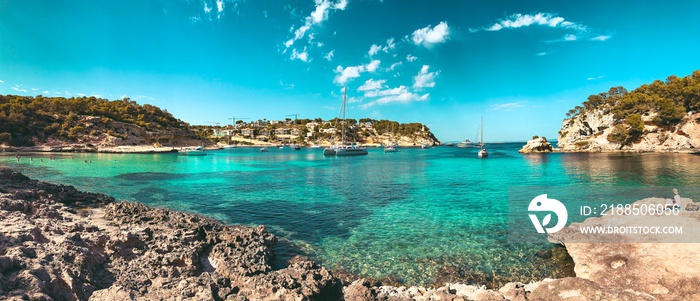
[557,70,700,152]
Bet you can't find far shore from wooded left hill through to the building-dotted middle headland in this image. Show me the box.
[0,95,440,152]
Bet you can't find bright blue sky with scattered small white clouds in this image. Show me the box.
[0,0,700,142]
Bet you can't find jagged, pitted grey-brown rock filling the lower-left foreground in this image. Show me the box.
[0,169,341,301]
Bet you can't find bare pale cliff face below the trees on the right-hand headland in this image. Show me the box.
[557,108,700,152]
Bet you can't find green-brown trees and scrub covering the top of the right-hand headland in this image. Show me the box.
[566,70,700,145]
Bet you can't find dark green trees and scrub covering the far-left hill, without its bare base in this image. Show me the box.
[0,95,189,146]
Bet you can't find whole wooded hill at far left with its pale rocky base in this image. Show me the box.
[0,95,202,150]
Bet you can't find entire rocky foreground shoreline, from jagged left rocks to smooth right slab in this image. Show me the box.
[0,169,700,301]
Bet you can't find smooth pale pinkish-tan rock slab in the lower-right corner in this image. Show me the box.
[549,198,700,300]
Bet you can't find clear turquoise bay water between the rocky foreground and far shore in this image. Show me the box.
[0,143,700,285]
